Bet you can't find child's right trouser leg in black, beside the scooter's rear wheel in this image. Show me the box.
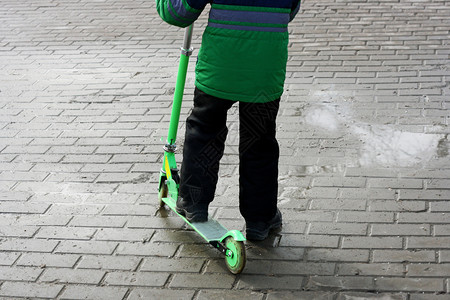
[239,99,280,222]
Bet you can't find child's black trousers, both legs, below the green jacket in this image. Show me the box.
[180,88,280,221]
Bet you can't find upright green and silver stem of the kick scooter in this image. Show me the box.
[166,24,194,146]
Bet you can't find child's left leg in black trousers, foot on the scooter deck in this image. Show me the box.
[177,89,234,222]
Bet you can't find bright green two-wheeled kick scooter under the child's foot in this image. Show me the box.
[158,25,246,274]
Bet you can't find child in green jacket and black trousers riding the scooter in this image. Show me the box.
[156,0,300,240]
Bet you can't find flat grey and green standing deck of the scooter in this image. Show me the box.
[162,197,228,242]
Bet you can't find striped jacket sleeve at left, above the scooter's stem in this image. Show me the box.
[156,0,208,27]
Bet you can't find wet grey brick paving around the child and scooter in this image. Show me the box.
[0,0,450,300]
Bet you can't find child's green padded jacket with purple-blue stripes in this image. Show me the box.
[156,0,300,103]
